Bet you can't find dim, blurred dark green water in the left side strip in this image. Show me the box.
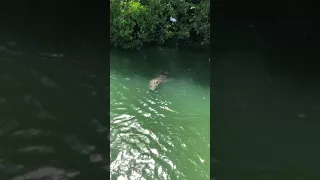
[0,31,109,180]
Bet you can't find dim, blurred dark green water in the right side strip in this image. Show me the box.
[211,18,320,180]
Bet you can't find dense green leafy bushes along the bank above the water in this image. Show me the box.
[110,0,210,49]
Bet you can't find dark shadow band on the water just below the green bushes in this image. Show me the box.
[111,46,210,86]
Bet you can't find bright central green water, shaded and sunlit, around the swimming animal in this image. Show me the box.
[110,48,210,180]
